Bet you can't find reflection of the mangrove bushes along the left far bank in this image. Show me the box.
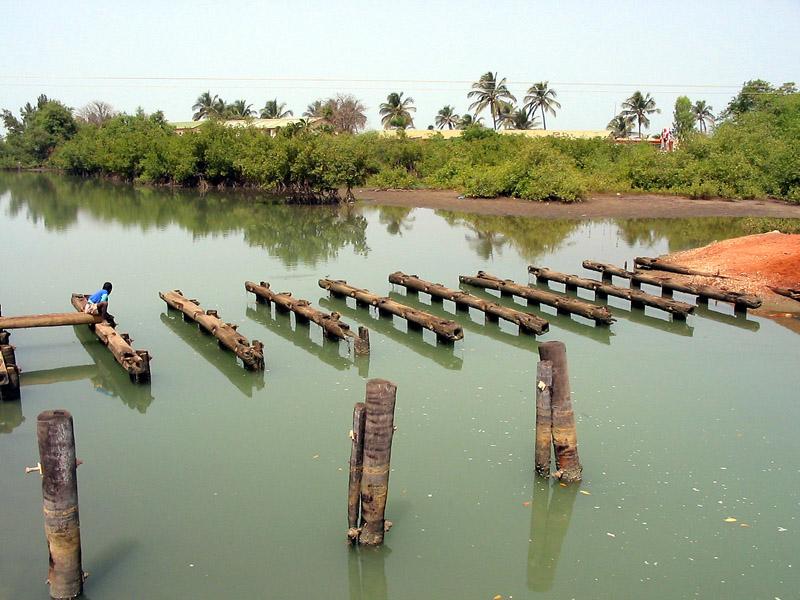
[0,173,369,265]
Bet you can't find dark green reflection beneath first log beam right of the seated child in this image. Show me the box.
[161,310,264,398]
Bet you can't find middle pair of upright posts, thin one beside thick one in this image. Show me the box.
[347,379,397,546]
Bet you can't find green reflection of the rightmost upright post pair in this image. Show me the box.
[528,477,579,592]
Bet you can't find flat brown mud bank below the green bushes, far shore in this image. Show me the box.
[353,188,800,219]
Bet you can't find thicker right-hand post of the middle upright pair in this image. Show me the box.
[358,379,397,546]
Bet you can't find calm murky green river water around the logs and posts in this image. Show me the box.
[0,173,800,600]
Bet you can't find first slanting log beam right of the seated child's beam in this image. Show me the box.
[158,290,264,371]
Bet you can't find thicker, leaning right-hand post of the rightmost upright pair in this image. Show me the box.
[539,342,583,483]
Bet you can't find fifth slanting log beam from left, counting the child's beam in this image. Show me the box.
[389,271,550,335]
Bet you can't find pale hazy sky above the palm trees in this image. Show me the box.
[0,0,800,132]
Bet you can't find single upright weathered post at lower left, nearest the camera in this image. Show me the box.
[36,410,84,599]
